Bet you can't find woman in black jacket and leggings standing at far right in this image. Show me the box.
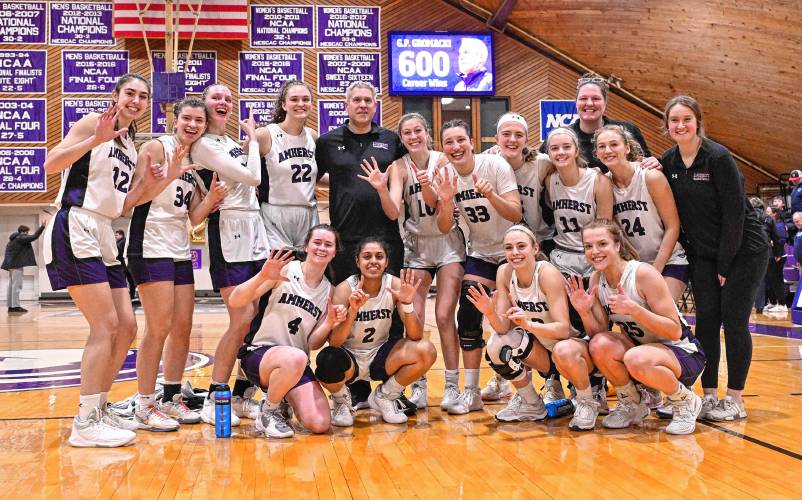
[660,96,769,421]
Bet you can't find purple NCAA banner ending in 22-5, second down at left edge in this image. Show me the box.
[0,50,47,94]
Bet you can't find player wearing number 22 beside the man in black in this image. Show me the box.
[256,80,318,251]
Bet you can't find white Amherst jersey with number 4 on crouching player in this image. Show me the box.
[249,260,331,354]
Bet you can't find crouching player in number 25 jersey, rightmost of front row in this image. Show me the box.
[558,219,705,434]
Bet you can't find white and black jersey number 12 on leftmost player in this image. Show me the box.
[56,136,137,219]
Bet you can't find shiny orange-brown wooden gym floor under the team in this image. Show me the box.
[0,301,802,499]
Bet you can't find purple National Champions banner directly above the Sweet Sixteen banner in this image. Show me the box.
[317,5,381,49]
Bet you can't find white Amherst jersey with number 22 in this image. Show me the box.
[262,123,317,207]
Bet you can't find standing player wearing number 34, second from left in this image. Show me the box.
[127,97,226,431]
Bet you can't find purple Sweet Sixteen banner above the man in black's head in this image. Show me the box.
[317,52,381,94]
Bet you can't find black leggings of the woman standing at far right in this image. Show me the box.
[691,248,768,391]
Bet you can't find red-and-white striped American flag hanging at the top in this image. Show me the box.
[114,0,248,40]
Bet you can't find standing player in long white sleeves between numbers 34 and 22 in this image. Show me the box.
[192,85,267,426]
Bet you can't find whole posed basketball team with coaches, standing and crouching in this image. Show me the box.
[45,69,769,447]
